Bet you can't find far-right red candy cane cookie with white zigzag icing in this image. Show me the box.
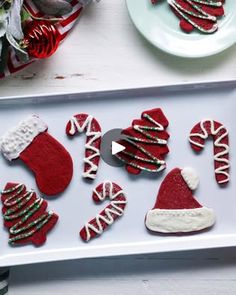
[189,119,230,184]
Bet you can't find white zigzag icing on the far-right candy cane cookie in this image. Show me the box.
[189,119,230,184]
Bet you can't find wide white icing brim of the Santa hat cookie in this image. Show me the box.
[145,207,215,233]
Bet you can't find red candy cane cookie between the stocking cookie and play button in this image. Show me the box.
[66,114,101,179]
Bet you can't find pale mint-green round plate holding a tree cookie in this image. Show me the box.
[126,0,236,58]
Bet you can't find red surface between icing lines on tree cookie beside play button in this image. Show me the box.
[118,108,169,174]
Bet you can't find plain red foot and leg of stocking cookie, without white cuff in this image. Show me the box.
[20,132,73,196]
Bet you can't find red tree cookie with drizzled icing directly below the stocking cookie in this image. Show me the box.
[1,183,58,246]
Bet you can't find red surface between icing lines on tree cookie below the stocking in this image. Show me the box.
[1,183,58,246]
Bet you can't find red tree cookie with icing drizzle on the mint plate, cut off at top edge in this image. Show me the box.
[168,0,224,33]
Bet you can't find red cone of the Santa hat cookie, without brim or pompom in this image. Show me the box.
[153,168,202,210]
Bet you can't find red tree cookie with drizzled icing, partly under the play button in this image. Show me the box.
[115,108,169,174]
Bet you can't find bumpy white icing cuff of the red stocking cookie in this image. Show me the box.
[0,115,48,161]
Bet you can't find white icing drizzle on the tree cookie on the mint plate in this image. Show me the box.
[168,0,218,33]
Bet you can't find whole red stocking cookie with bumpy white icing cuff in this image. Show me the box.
[0,115,73,196]
